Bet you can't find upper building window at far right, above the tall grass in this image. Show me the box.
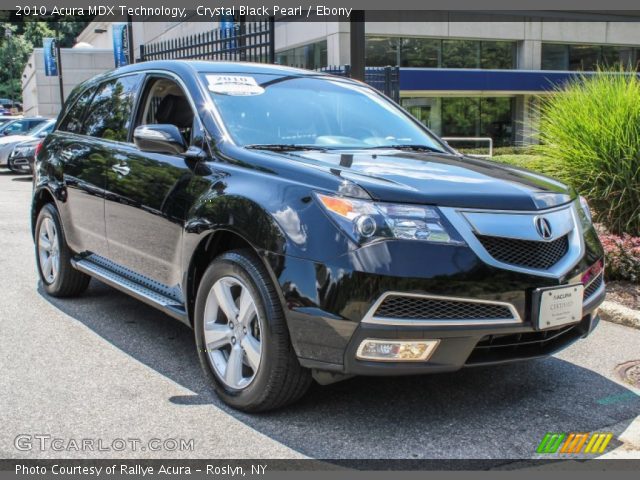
[542,43,640,71]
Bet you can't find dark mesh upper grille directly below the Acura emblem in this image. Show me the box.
[477,235,569,270]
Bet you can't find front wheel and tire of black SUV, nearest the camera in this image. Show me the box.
[194,250,311,412]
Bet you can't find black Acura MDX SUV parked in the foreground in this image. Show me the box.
[32,61,605,411]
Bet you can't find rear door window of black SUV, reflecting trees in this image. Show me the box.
[83,75,141,142]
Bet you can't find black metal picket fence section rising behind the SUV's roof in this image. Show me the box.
[140,18,275,63]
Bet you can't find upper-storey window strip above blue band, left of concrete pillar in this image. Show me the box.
[366,36,517,69]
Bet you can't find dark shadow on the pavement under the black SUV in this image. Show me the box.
[40,280,640,459]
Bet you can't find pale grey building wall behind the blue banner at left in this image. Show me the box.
[22,48,114,117]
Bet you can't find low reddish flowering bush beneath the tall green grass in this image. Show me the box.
[596,225,640,282]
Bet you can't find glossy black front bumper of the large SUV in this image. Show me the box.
[266,234,605,375]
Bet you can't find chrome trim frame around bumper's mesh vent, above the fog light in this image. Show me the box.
[361,291,522,327]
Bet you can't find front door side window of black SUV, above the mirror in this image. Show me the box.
[135,77,195,145]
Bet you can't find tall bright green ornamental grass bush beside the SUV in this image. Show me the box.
[536,71,640,236]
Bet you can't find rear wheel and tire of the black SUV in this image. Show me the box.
[35,203,91,297]
